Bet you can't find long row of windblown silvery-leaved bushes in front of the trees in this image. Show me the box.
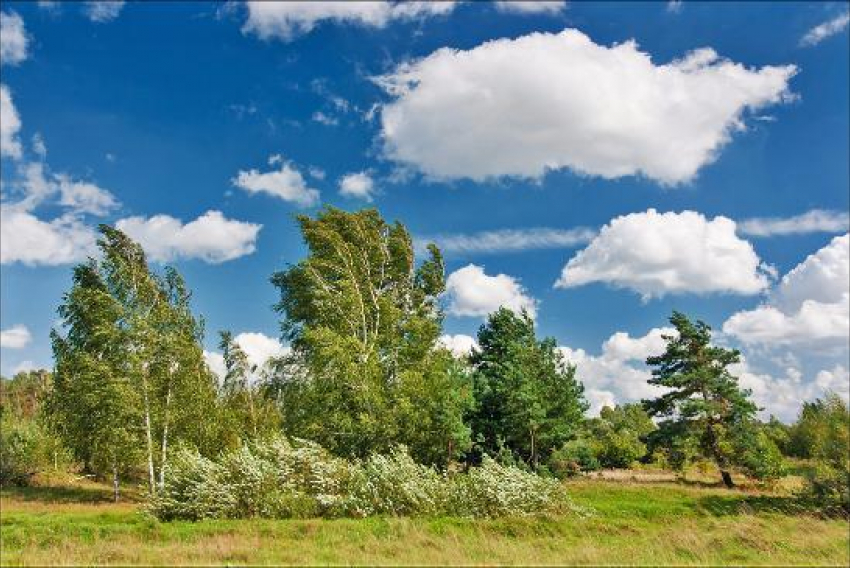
[147,438,571,521]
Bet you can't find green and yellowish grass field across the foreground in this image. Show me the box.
[0,478,850,566]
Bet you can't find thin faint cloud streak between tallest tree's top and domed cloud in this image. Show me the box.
[417,227,596,254]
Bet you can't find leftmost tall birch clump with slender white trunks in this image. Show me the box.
[49,225,215,496]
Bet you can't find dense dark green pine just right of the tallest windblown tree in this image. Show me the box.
[470,308,587,469]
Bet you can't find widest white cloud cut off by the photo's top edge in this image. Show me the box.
[242,1,455,41]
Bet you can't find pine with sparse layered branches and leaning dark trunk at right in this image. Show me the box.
[643,311,763,487]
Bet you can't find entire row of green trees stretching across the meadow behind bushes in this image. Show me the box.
[2,207,850,508]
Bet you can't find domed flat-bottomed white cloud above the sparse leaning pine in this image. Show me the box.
[555,209,771,299]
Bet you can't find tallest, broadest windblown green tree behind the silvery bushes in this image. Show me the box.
[272,207,469,463]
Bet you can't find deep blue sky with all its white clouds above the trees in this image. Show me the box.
[0,1,850,417]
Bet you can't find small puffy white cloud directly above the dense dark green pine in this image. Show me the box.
[445,264,537,318]
